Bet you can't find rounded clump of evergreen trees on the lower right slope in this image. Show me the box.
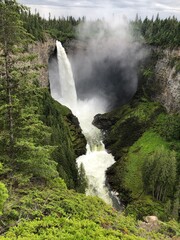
[142,147,176,201]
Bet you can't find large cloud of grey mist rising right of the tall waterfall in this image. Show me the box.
[69,17,147,110]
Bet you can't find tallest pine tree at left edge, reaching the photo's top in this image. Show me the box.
[0,0,31,159]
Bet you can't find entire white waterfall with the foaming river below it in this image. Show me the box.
[50,41,118,205]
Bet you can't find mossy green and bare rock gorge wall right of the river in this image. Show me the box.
[93,48,180,211]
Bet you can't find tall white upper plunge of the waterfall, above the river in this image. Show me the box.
[52,41,77,109]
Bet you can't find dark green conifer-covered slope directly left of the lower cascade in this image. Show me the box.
[37,89,86,188]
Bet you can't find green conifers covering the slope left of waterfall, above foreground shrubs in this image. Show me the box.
[0,1,86,188]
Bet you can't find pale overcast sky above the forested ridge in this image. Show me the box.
[18,0,180,19]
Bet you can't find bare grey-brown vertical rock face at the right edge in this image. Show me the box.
[154,49,180,112]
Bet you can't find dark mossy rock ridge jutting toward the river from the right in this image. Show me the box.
[93,98,164,160]
